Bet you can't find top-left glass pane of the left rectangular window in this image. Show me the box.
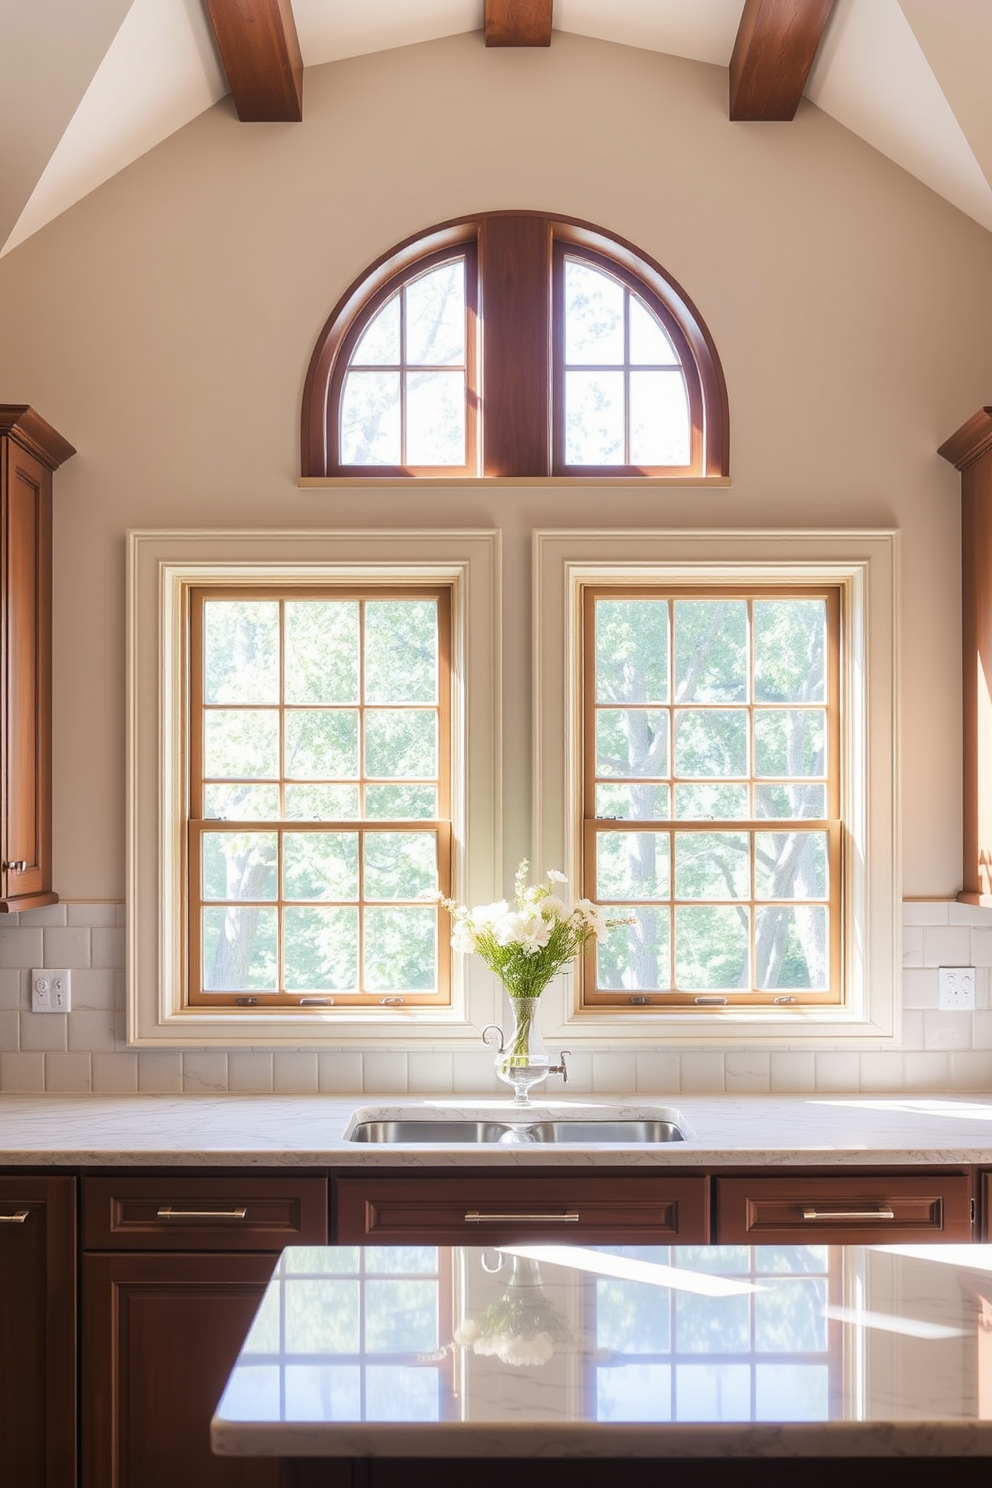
[204,600,280,702]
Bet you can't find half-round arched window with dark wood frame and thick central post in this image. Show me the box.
[303,213,729,481]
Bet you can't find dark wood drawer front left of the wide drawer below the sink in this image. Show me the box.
[83,1177,327,1251]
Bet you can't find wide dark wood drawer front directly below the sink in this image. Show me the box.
[336,1176,709,1245]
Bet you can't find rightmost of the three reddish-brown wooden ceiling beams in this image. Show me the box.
[730,0,834,121]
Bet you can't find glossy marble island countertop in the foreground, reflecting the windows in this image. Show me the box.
[211,1245,992,1458]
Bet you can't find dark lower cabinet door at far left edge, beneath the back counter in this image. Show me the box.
[0,1177,76,1488]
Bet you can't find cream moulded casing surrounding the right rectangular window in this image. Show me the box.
[532,528,901,1049]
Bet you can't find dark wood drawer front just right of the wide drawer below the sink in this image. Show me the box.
[715,1173,971,1245]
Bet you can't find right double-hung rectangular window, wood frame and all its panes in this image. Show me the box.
[583,586,840,1009]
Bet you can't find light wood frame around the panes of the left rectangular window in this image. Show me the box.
[184,583,454,1016]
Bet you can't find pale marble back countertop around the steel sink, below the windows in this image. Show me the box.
[0,1092,992,1170]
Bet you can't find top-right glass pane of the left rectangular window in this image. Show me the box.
[364,600,437,702]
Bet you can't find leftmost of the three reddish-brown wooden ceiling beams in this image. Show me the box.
[207,0,303,124]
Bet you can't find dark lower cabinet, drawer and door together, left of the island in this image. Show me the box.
[80,1173,327,1488]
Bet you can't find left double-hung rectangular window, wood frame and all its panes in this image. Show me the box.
[187,586,451,1007]
